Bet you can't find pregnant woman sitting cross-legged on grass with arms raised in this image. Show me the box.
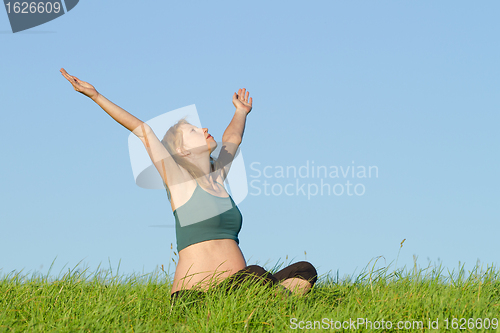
[61,69,317,297]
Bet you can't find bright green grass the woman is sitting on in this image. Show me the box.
[0,264,500,332]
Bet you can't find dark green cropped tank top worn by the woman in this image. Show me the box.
[171,183,243,251]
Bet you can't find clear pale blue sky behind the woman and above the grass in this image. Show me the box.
[0,0,500,282]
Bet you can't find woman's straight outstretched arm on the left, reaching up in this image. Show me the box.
[61,68,181,186]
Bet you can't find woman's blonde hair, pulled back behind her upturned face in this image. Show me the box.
[161,118,219,184]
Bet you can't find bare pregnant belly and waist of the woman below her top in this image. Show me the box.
[172,239,246,293]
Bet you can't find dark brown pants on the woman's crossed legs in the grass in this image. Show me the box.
[170,261,318,299]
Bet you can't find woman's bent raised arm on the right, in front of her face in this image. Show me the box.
[218,89,253,178]
